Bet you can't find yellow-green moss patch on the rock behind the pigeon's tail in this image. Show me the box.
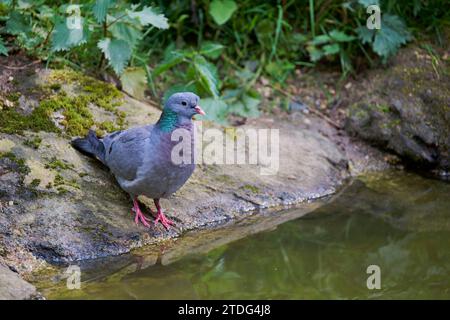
[0,70,125,136]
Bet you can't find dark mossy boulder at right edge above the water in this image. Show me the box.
[346,45,450,174]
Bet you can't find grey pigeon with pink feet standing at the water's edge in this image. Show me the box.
[72,92,205,229]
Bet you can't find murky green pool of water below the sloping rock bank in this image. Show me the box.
[37,173,450,299]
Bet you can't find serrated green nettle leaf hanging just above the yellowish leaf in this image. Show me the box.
[97,38,132,74]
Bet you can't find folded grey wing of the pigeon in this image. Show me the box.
[103,126,153,181]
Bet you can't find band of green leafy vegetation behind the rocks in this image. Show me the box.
[0,0,450,123]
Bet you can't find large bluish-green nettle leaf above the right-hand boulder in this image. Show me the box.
[373,14,411,59]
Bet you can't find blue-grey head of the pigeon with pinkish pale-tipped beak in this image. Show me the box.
[164,92,205,119]
